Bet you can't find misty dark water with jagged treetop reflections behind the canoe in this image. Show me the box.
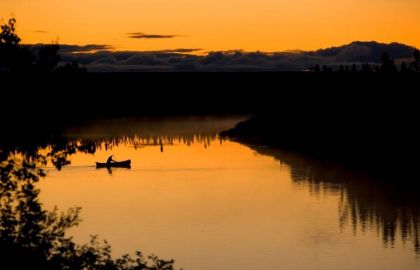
[64,116,236,152]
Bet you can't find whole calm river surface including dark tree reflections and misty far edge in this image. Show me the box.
[40,118,420,270]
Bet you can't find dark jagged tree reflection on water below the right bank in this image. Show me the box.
[244,143,420,254]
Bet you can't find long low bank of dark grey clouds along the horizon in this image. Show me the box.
[40,42,414,72]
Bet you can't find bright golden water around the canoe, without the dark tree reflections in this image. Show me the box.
[40,140,417,270]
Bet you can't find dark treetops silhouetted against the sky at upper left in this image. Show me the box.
[0,18,86,72]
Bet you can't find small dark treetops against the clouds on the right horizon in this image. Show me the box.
[309,49,420,73]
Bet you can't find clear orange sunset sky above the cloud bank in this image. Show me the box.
[0,0,420,52]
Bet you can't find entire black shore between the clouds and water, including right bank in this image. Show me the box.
[0,72,420,177]
